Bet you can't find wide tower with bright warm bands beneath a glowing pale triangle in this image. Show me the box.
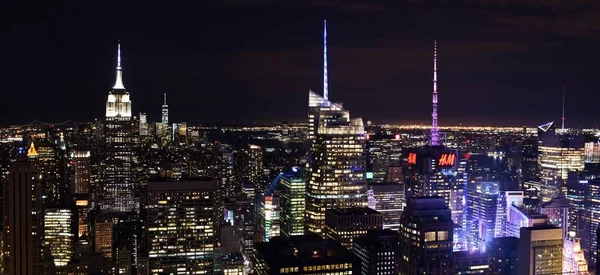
[538,122,585,202]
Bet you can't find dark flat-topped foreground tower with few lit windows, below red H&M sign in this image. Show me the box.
[400,197,454,275]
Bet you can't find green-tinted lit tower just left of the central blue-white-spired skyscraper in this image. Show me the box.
[279,167,306,237]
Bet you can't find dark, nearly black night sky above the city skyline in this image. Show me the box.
[0,0,600,127]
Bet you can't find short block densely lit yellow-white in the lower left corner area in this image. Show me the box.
[44,208,75,268]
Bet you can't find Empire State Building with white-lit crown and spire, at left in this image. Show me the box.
[101,44,136,212]
